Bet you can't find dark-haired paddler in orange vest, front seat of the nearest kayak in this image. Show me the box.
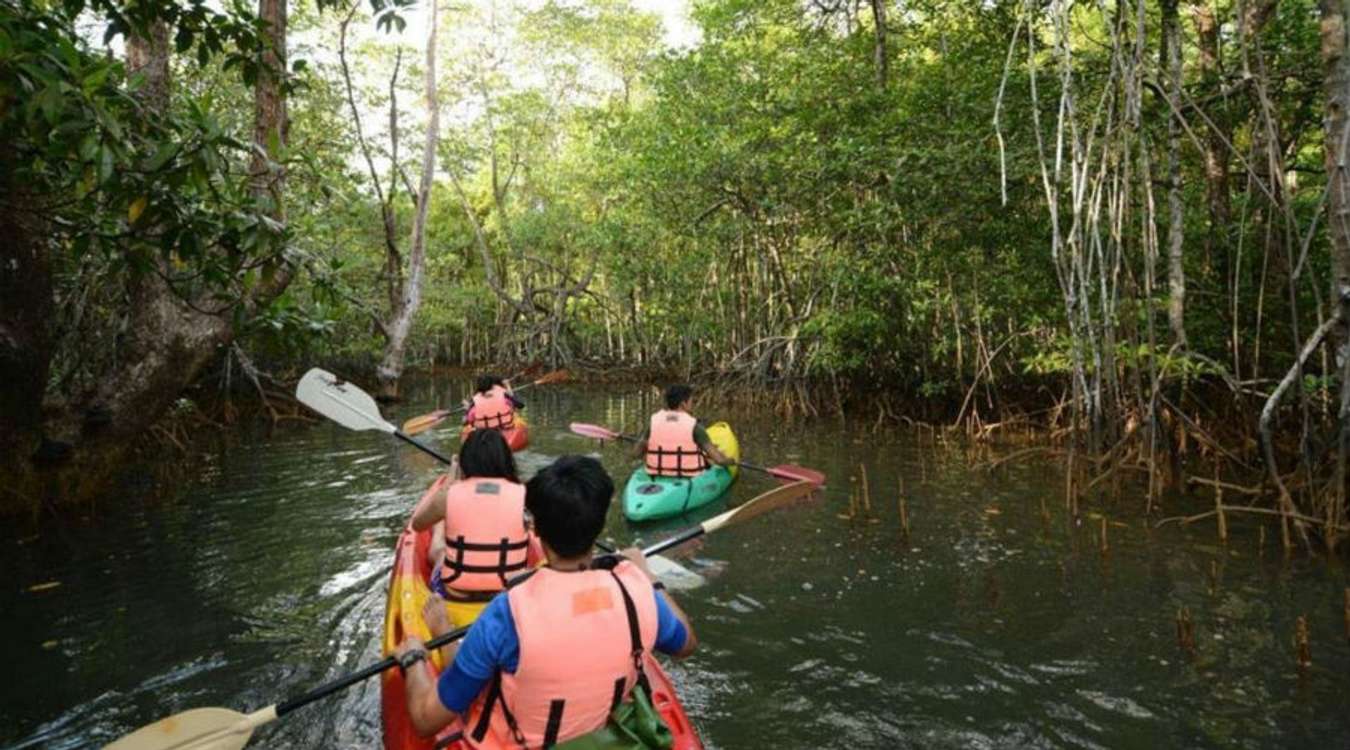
[412,430,543,630]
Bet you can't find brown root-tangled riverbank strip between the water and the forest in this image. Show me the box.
[15,363,1350,550]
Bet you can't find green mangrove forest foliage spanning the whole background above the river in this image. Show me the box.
[15,0,1328,412]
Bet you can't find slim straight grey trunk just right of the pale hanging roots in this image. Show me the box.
[1161,0,1187,349]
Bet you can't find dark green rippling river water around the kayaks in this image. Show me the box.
[0,384,1350,749]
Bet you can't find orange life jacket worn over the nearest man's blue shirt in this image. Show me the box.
[464,561,656,749]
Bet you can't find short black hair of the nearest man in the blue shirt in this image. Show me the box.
[525,456,614,557]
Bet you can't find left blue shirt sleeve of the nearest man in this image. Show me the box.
[436,594,520,714]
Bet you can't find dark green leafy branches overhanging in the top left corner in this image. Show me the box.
[0,4,284,299]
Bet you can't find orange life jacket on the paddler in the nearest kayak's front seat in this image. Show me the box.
[440,478,529,592]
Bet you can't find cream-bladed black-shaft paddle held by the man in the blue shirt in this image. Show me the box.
[104,482,815,750]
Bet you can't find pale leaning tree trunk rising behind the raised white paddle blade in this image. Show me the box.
[375,3,440,399]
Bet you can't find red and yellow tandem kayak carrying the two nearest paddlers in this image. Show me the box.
[379,496,703,750]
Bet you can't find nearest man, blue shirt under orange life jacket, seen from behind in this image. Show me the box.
[396,456,697,747]
